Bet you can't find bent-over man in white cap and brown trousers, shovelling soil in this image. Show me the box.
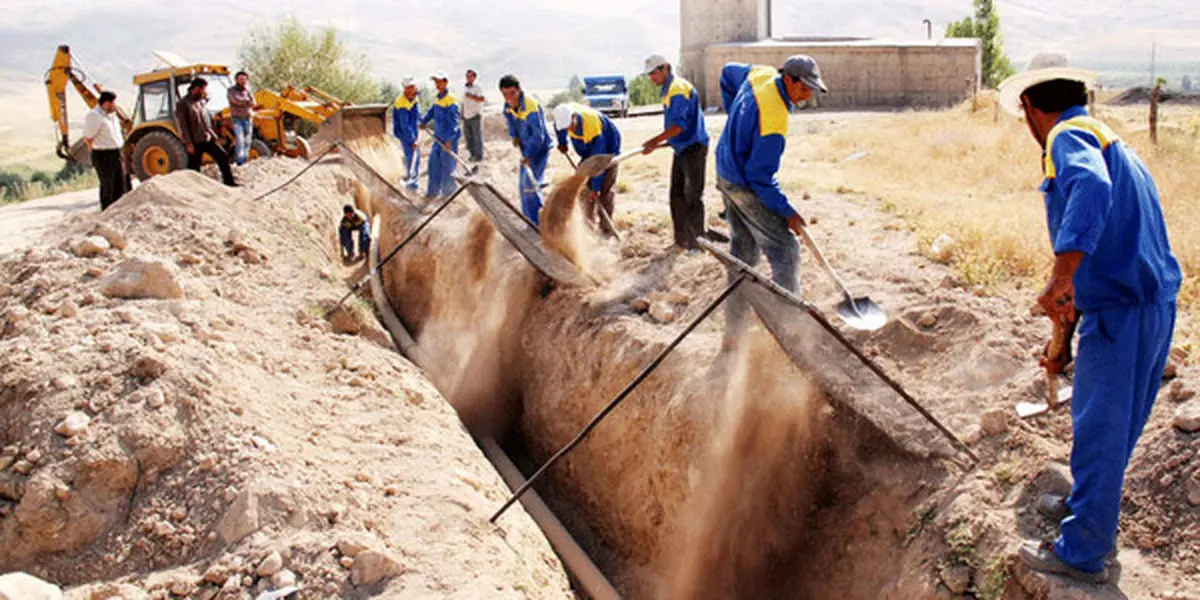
[554,102,620,238]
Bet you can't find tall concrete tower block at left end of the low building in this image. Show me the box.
[679,0,770,99]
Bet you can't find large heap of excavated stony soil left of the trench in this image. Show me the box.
[0,160,571,599]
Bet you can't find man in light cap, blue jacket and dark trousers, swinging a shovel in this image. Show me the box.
[642,54,708,250]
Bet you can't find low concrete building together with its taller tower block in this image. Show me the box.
[679,0,983,108]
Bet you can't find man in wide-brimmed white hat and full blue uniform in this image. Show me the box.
[1000,54,1182,583]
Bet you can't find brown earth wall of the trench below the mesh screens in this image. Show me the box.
[348,138,948,599]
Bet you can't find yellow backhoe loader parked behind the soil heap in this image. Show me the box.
[46,46,349,180]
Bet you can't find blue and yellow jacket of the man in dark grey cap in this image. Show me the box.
[716,62,796,218]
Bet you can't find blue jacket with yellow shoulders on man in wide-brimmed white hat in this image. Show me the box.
[1042,107,1182,311]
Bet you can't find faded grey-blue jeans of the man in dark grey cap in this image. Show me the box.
[716,179,800,341]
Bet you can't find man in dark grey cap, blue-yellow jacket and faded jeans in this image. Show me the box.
[716,54,828,349]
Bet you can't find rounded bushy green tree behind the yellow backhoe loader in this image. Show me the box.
[238,17,380,102]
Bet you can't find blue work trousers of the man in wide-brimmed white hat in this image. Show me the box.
[1055,302,1175,572]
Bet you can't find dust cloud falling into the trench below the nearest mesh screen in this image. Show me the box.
[658,331,826,599]
